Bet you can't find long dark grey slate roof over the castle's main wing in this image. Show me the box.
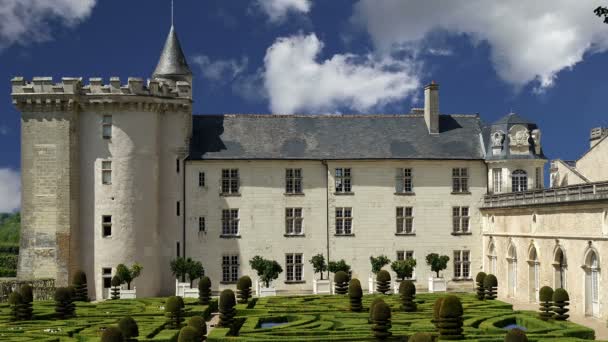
[189,114,484,160]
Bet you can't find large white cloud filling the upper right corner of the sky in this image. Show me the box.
[353,0,608,90]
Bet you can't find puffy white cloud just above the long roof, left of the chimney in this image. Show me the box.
[264,34,419,113]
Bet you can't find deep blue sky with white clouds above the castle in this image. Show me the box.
[0,0,608,212]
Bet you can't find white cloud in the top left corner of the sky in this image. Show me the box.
[0,0,96,48]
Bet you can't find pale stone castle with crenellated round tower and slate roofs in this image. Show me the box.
[12,27,608,317]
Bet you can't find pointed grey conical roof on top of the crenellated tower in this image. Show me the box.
[152,26,192,80]
